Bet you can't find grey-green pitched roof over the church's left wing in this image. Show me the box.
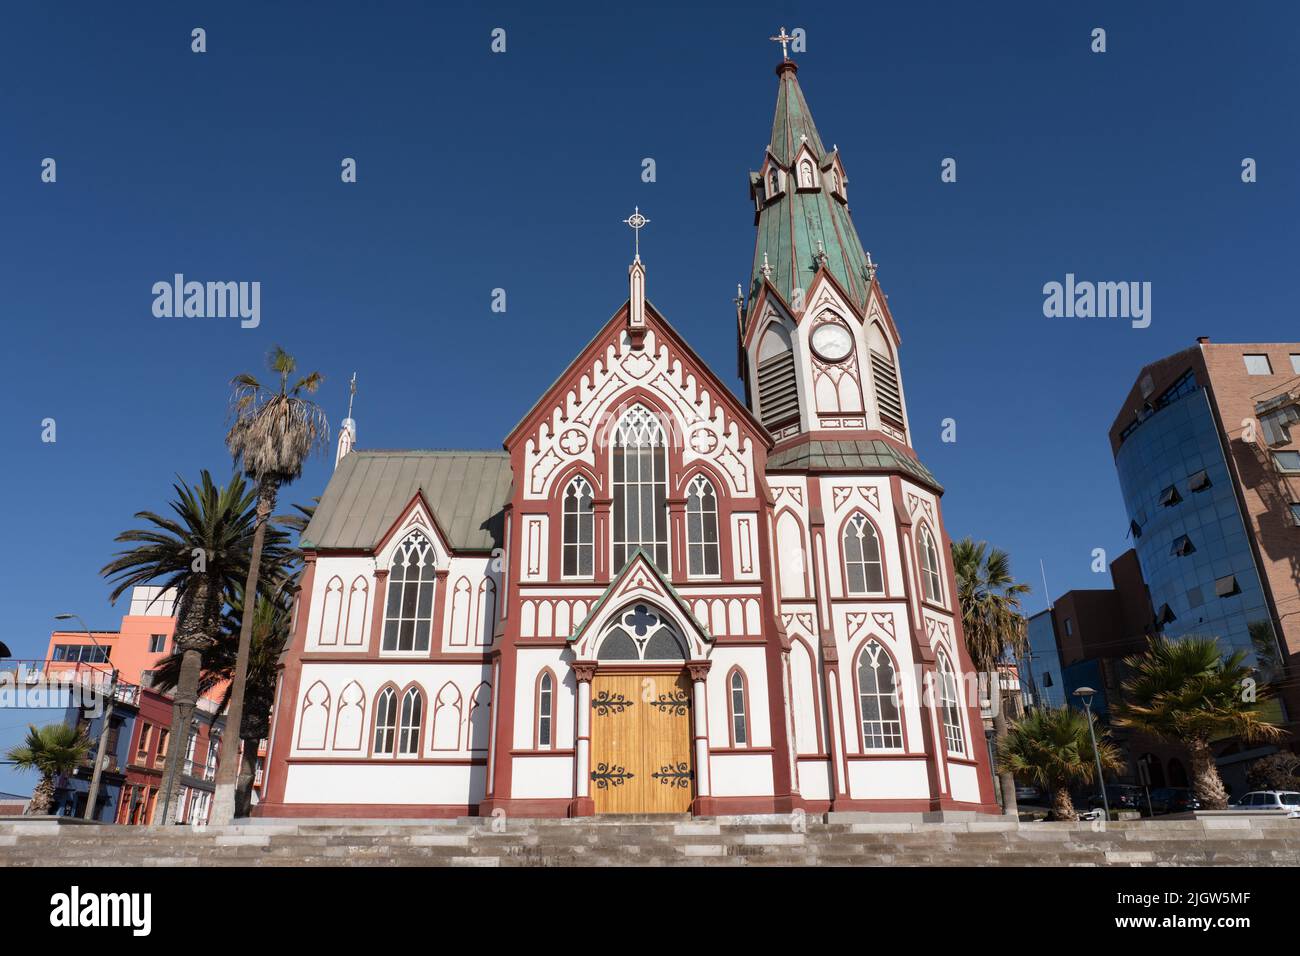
[302,450,512,551]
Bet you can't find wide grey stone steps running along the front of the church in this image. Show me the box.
[0,816,1300,866]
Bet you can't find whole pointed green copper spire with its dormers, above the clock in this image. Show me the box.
[746,60,870,329]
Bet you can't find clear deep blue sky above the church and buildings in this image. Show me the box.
[0,3,1300,657]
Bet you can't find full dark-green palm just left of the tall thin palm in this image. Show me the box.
[100,471,266,821]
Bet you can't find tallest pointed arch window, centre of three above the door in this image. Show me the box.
[614,405,668,574]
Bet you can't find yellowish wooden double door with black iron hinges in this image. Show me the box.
[589,671,696,813]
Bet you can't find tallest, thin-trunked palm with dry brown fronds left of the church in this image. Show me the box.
[212,345,329,825]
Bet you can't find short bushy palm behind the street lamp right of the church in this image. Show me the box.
[997,708,1125,821]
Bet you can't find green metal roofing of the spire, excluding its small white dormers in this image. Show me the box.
[750,61,868,329]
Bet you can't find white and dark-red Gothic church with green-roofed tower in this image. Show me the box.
[256,48,998,818]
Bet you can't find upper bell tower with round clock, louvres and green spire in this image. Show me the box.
[738,53,910,451]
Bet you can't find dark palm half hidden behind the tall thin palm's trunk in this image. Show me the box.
[153,580,295,817]
